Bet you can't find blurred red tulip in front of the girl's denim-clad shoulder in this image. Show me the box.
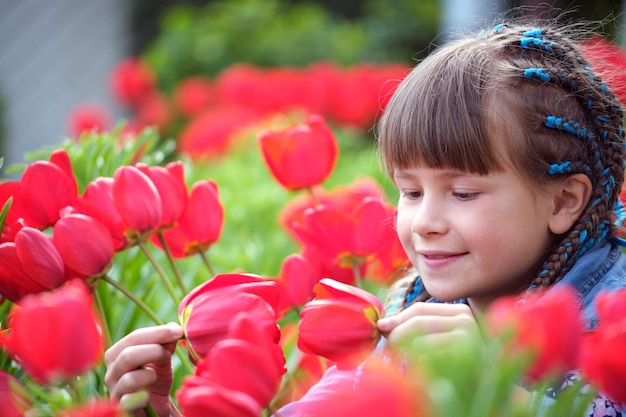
[487,285,583,382]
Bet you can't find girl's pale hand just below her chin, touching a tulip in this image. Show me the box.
[378,303,479,348]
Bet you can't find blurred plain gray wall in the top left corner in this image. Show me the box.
[0,0,128,174]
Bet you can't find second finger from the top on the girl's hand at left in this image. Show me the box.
[104,344,172,388]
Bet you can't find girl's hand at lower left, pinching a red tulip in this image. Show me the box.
[104,323,183,417]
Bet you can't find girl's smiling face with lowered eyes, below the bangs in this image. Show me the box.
[394,167,554,305]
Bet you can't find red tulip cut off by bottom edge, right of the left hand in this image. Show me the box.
[176,376,263,417]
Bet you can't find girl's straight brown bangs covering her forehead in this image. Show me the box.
[378,46,502,176]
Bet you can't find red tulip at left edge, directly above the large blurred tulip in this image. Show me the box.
[0,227,65,302]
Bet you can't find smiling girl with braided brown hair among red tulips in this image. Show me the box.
[105,18,626,417]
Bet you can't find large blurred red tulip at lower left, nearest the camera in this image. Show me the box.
[0,280,104,384]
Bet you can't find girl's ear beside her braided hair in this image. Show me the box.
[548,174,592,235]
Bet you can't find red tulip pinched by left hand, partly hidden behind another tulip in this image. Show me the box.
[178,274,280,361]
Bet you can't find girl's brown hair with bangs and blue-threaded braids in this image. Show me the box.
[377,22,624,302]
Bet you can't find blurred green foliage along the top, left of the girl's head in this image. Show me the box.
[143,0,440,91]
